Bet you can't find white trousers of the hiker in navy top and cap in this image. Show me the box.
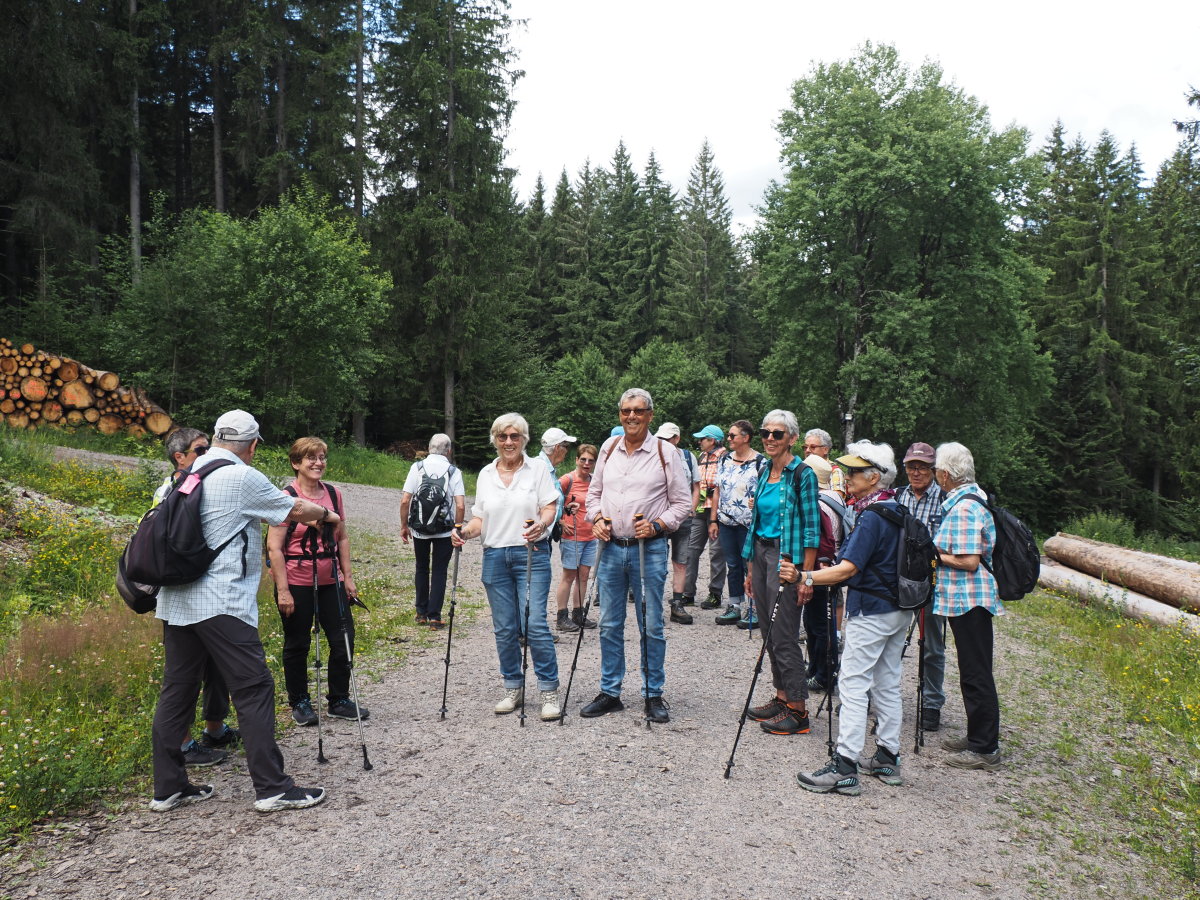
[838,610,912,760]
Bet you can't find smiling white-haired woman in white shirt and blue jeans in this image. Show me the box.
[451,413,563,721]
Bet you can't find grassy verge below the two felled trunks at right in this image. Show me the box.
[1004,593,1200,898]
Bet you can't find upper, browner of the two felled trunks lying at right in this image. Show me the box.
[1045,532,1200,612]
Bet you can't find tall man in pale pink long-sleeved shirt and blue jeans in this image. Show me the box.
[580,388,691,722]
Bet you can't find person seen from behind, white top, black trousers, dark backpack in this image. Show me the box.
[400,433,467,628]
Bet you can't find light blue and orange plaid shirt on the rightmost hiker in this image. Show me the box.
[934,484,1004,616]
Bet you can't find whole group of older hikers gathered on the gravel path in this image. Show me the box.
[142,389,1003,811]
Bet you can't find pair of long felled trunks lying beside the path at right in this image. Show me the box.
[1039,532,1200,632]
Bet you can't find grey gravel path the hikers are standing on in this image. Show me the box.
[0,453,1175,899]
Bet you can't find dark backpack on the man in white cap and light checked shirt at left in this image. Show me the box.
[116,460,242,613]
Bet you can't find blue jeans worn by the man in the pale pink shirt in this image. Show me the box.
[596,538,667,697]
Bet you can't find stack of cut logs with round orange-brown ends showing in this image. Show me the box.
[0,337,174,434]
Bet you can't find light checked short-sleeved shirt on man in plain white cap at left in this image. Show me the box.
[155,446,295,628]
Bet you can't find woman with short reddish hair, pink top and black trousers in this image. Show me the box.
[266,438,370,725]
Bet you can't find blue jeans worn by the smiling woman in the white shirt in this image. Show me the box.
[484,540,558,691]
